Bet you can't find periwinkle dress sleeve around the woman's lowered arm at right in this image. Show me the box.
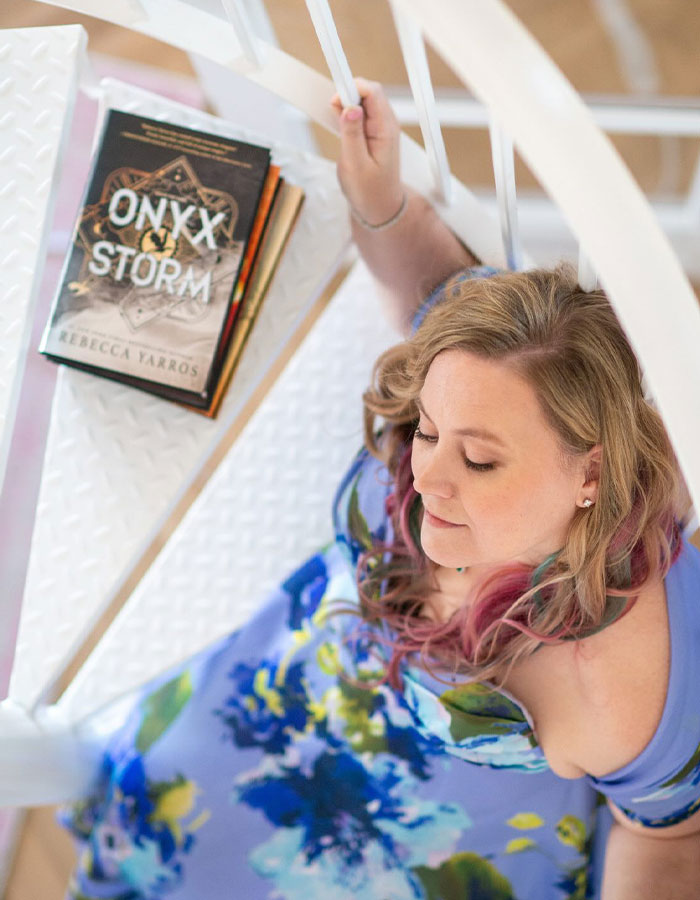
[588,544,700,828]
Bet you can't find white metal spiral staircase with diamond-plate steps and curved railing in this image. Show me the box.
[0,0,700,884]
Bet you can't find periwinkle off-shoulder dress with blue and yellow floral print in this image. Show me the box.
[63,273,700,900]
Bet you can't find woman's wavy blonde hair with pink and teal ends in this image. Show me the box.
[357,266,689,684]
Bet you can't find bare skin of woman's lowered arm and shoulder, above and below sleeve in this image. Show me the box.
[514,580,700,900]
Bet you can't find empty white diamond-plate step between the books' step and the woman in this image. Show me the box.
[59,256,399,720]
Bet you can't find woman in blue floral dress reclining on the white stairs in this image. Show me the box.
[67,82,700,900]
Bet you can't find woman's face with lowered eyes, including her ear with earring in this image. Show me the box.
[412,350,598,568]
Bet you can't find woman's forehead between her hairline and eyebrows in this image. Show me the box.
[419,350,557,447]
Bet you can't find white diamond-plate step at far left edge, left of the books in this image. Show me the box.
[0,25,85,486]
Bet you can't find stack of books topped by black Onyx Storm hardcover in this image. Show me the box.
[40,110,304,416]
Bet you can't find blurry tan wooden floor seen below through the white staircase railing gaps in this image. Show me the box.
[0,0,700,900]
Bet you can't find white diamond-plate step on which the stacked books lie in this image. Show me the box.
[15,81,356,706]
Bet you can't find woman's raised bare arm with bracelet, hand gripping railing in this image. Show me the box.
[333,79,478,333]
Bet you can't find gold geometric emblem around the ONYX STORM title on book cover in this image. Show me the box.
[72,156,242,331]
